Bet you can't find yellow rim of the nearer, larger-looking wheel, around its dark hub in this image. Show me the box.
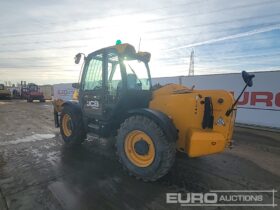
[124,130,155,167]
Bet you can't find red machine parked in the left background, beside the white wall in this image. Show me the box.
[21,81,45,102]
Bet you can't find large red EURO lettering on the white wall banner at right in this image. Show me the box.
[232,91,280,107]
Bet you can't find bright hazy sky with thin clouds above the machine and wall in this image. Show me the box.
[0,0,280,84]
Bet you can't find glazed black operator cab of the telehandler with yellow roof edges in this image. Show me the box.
[75,44,152,135]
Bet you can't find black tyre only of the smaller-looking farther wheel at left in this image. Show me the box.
[60,106,87,145]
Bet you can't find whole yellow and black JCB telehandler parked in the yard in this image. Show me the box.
[54,44,254,181]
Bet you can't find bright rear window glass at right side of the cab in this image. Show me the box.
[123,60,151,90]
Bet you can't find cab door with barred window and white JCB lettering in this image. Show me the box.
[79,53,104,119]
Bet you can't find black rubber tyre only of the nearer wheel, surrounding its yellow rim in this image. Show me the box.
[116,115,176,181]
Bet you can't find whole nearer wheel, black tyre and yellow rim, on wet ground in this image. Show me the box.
[116,115,176,181]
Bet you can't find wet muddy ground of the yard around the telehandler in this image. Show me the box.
[0,101,280,210]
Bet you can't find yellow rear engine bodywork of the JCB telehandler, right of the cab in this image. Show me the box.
[149,84,235,157]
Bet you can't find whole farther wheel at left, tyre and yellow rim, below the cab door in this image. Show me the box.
[60,106,86,145]
